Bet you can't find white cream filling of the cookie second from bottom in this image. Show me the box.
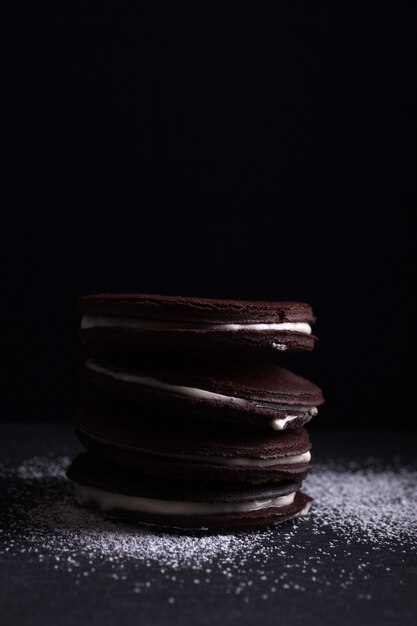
[85,432,311,467]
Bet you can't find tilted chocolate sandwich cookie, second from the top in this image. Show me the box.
[82,357,323,430]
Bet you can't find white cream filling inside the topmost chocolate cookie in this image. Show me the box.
[81,315,312,335]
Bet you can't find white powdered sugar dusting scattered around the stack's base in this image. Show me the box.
[0,455,417,604]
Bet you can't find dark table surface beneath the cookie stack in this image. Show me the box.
[0,423,417,626]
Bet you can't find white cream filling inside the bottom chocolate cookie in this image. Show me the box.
[74,483,295,515]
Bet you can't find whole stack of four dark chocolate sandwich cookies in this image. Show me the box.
[68,294,323,530]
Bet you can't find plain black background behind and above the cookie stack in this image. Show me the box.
[1,1,417,427]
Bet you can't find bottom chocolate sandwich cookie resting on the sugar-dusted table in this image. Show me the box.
[68,454,311,530]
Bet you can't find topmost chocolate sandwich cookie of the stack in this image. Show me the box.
[79,294,315,356]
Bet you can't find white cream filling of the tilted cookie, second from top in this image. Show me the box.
[85,359,317,430]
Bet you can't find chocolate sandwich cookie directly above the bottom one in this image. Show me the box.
[74,394,311,483]
